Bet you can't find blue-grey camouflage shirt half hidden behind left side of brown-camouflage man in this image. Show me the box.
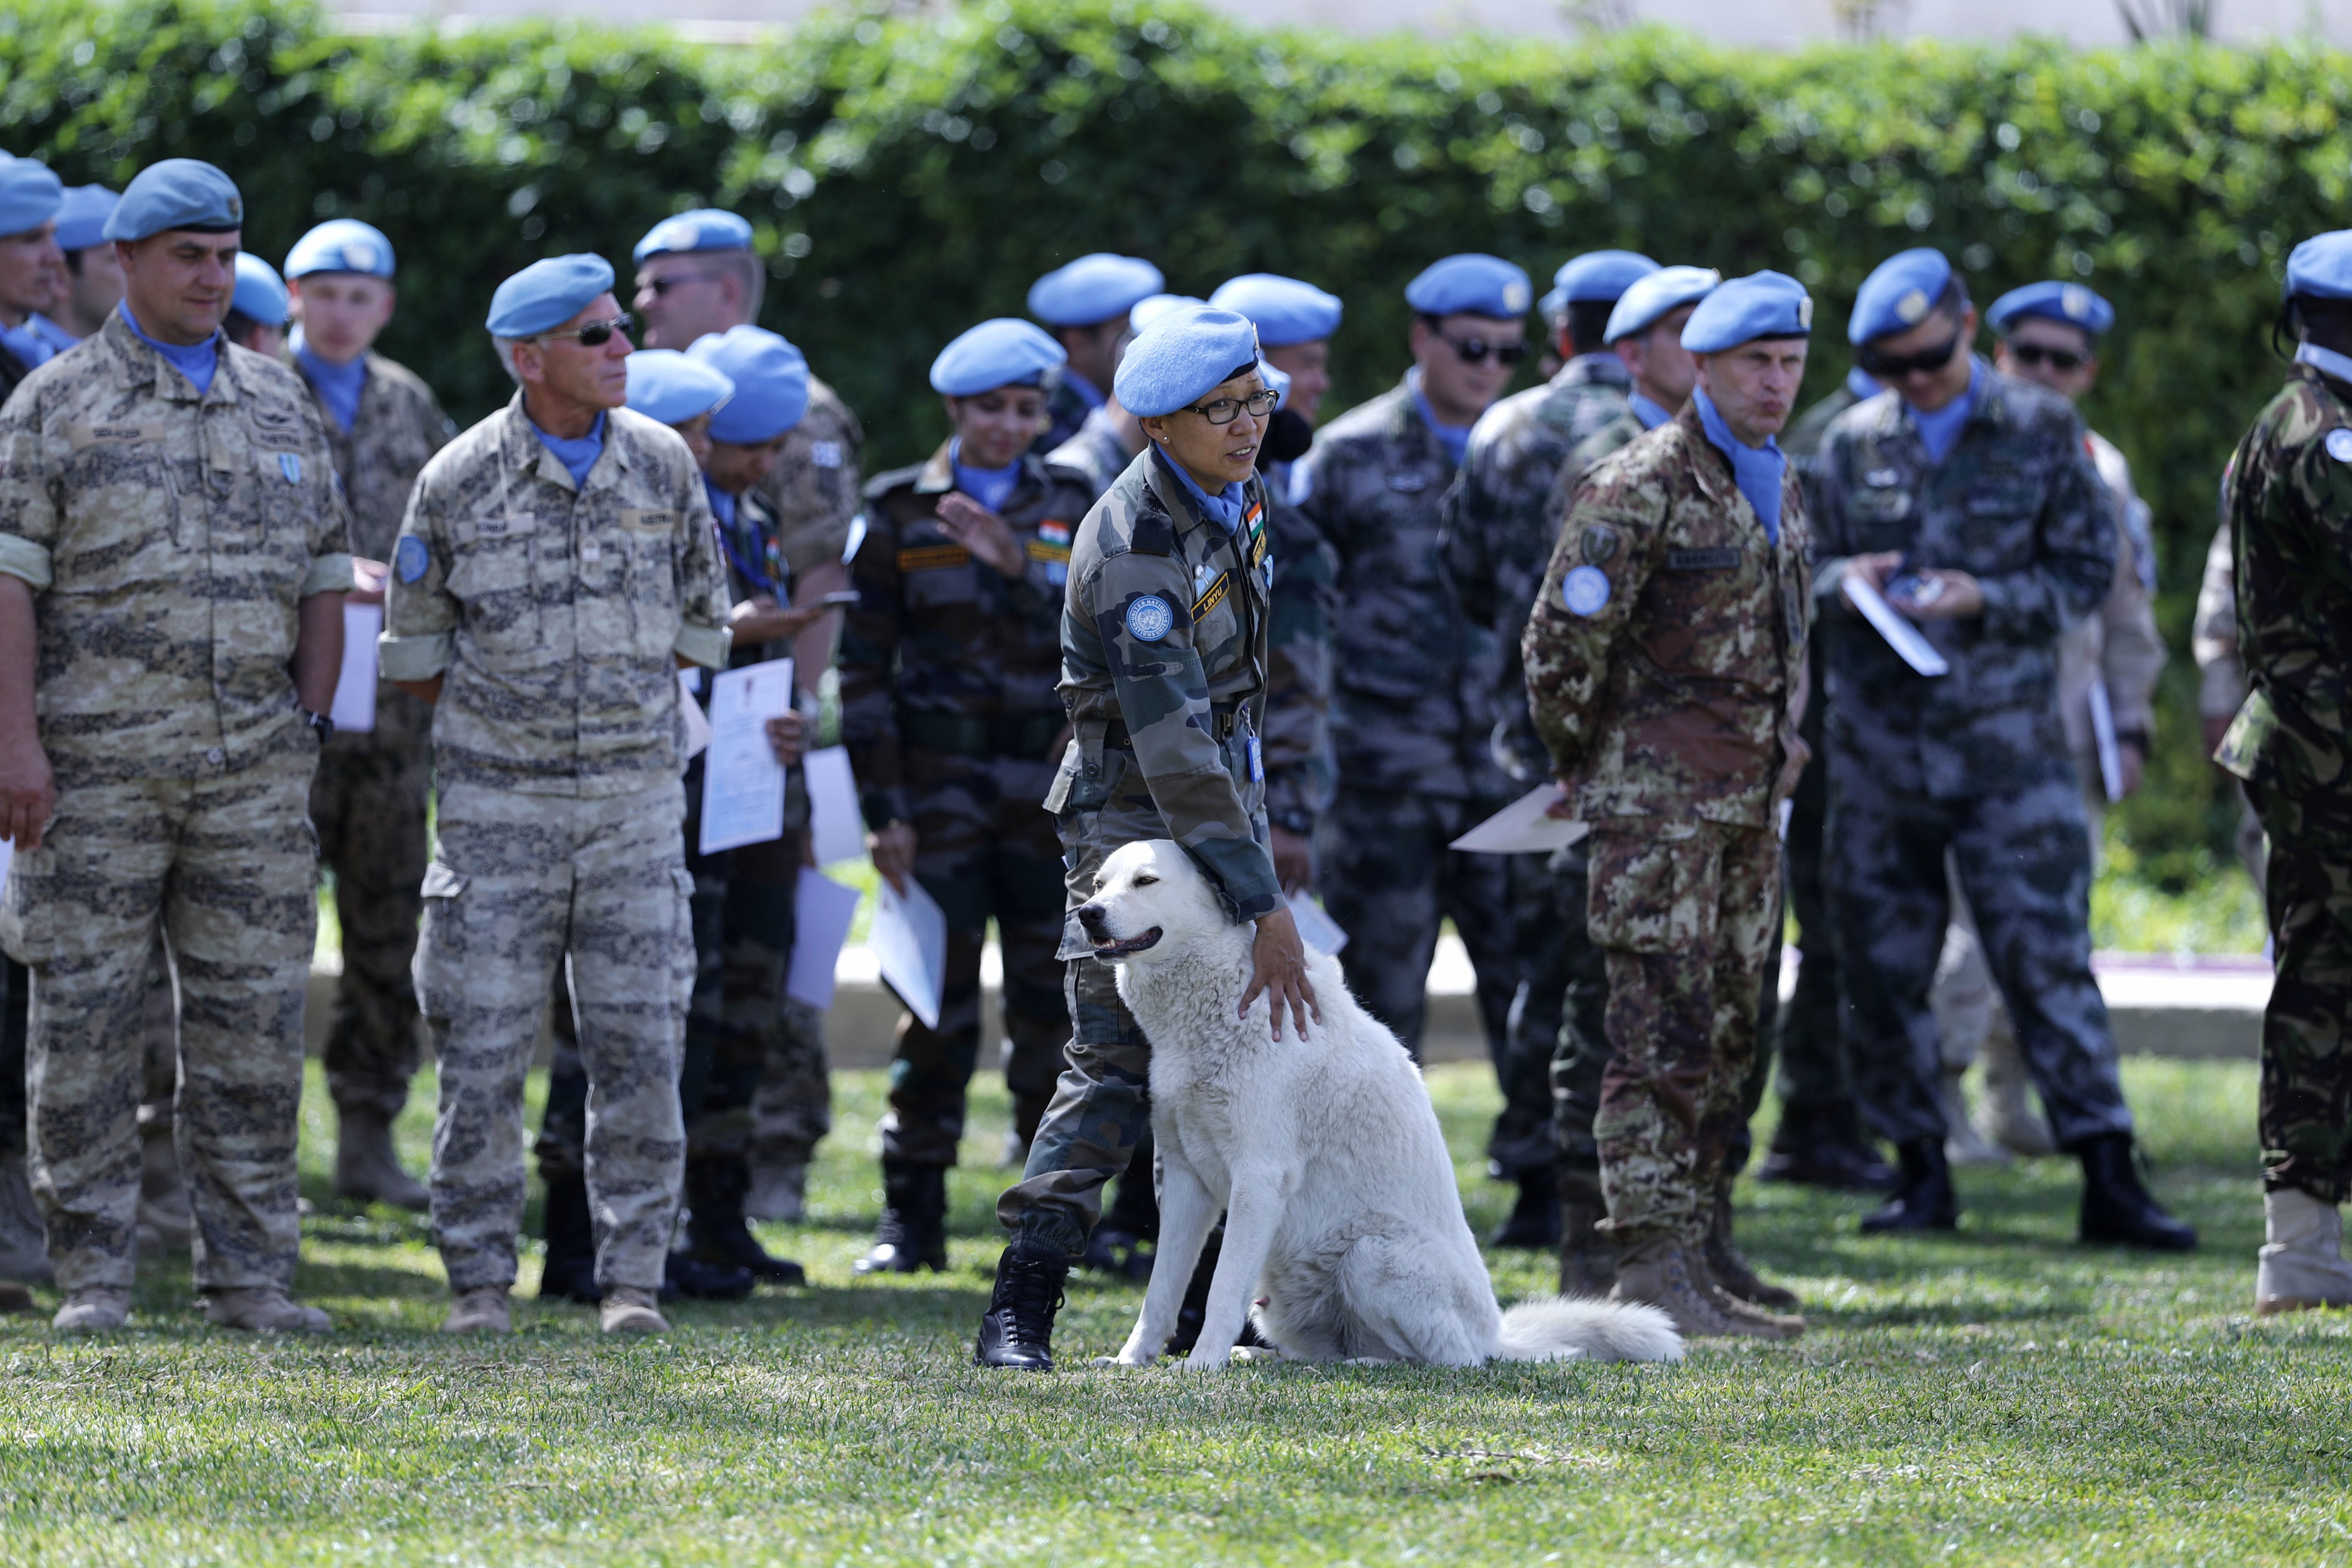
[1439,352,1642,783]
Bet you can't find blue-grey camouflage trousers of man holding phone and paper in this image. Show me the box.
[1828,752,2131,1147]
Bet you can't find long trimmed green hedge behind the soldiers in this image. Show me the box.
[0,0,2352,884]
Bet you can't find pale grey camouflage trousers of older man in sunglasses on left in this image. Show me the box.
[416,783,694,1291]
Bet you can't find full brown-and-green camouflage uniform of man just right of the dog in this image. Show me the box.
[1524,407,1809,1251]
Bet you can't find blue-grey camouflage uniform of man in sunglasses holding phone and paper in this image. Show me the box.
[1813,362,2131,1147]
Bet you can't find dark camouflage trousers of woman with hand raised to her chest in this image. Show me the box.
[882,747,1070,1166]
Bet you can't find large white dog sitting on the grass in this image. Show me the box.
[1077,839,1681,1368]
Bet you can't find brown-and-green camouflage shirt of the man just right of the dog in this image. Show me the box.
[1524,407,1811,827]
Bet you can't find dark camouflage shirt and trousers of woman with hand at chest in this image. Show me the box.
[842,447,1089,1166]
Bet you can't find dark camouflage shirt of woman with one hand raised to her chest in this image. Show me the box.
[840,447,1093,825]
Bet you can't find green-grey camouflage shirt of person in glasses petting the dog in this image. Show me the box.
[1047,449,1282,919]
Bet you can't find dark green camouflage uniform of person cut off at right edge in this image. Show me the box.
[2218,367,2352,1204]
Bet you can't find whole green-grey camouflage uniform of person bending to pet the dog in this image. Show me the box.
[997,451,1282,1258]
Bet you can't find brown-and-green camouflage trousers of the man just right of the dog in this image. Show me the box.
[1588,818,1780,1243]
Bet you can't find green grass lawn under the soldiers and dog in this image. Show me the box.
[0,1060,2352,1568]
